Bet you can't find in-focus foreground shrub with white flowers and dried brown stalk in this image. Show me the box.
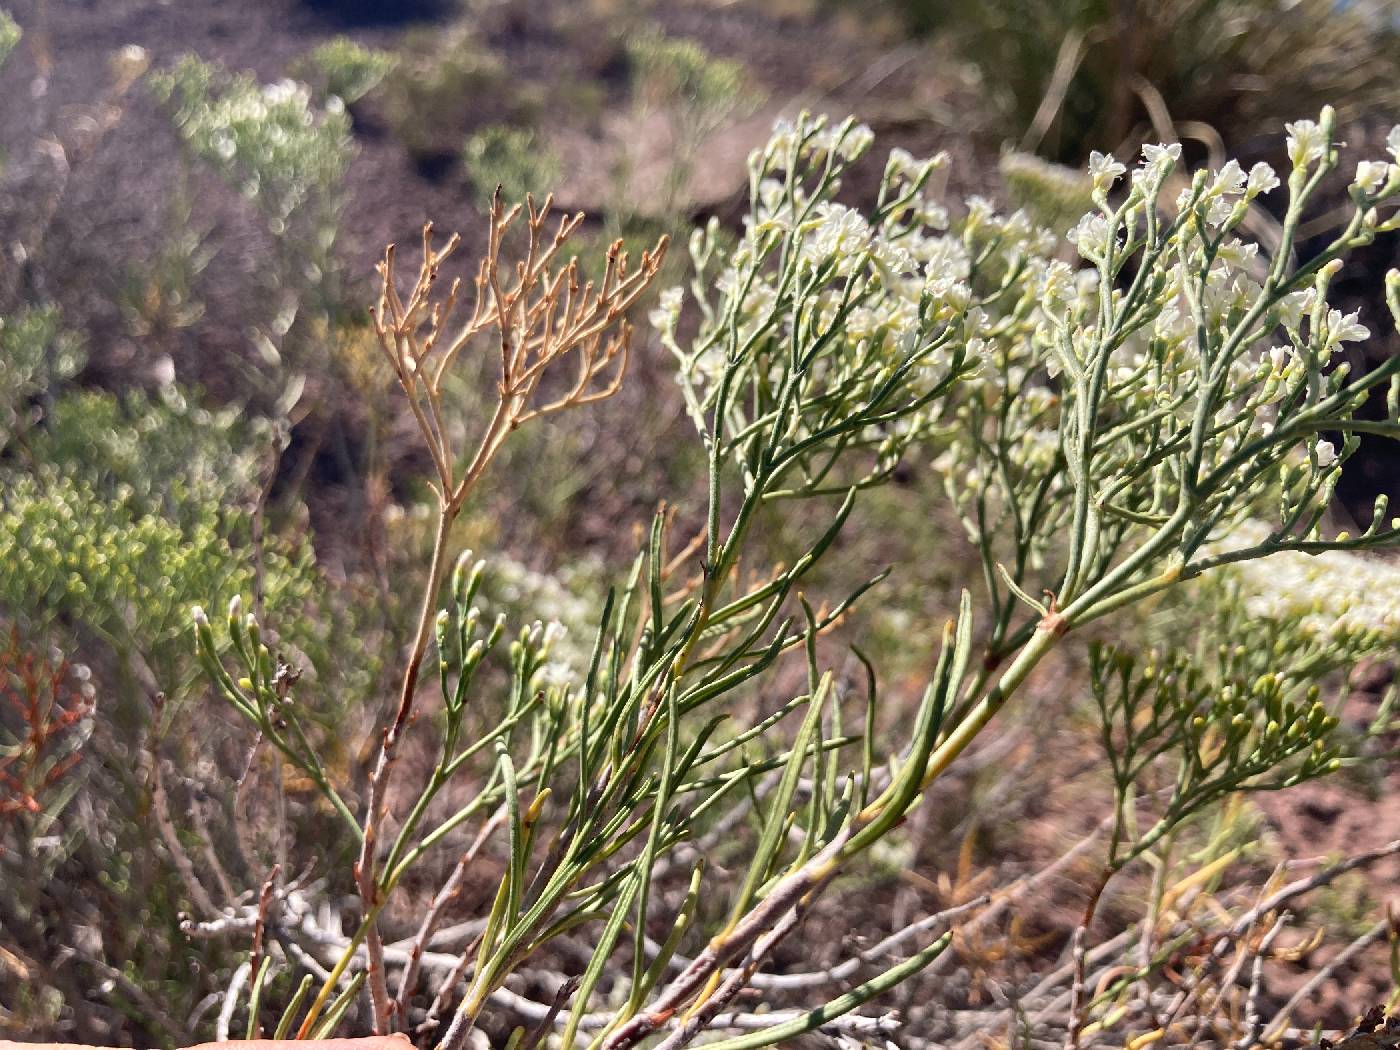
[180,111,1400,1050]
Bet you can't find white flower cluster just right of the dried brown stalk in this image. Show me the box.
[652,115,1024,498]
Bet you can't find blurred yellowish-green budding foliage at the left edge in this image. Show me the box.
[0,375,321,693]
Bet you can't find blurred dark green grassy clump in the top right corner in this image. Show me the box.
[899,0,1400,164]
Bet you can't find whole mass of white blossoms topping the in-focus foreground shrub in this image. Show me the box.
[654,113,1400,596]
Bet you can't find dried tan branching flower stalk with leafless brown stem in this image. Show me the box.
[350,197,666,1035]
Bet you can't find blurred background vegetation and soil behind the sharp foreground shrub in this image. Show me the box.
[0,0,1400,1044]
